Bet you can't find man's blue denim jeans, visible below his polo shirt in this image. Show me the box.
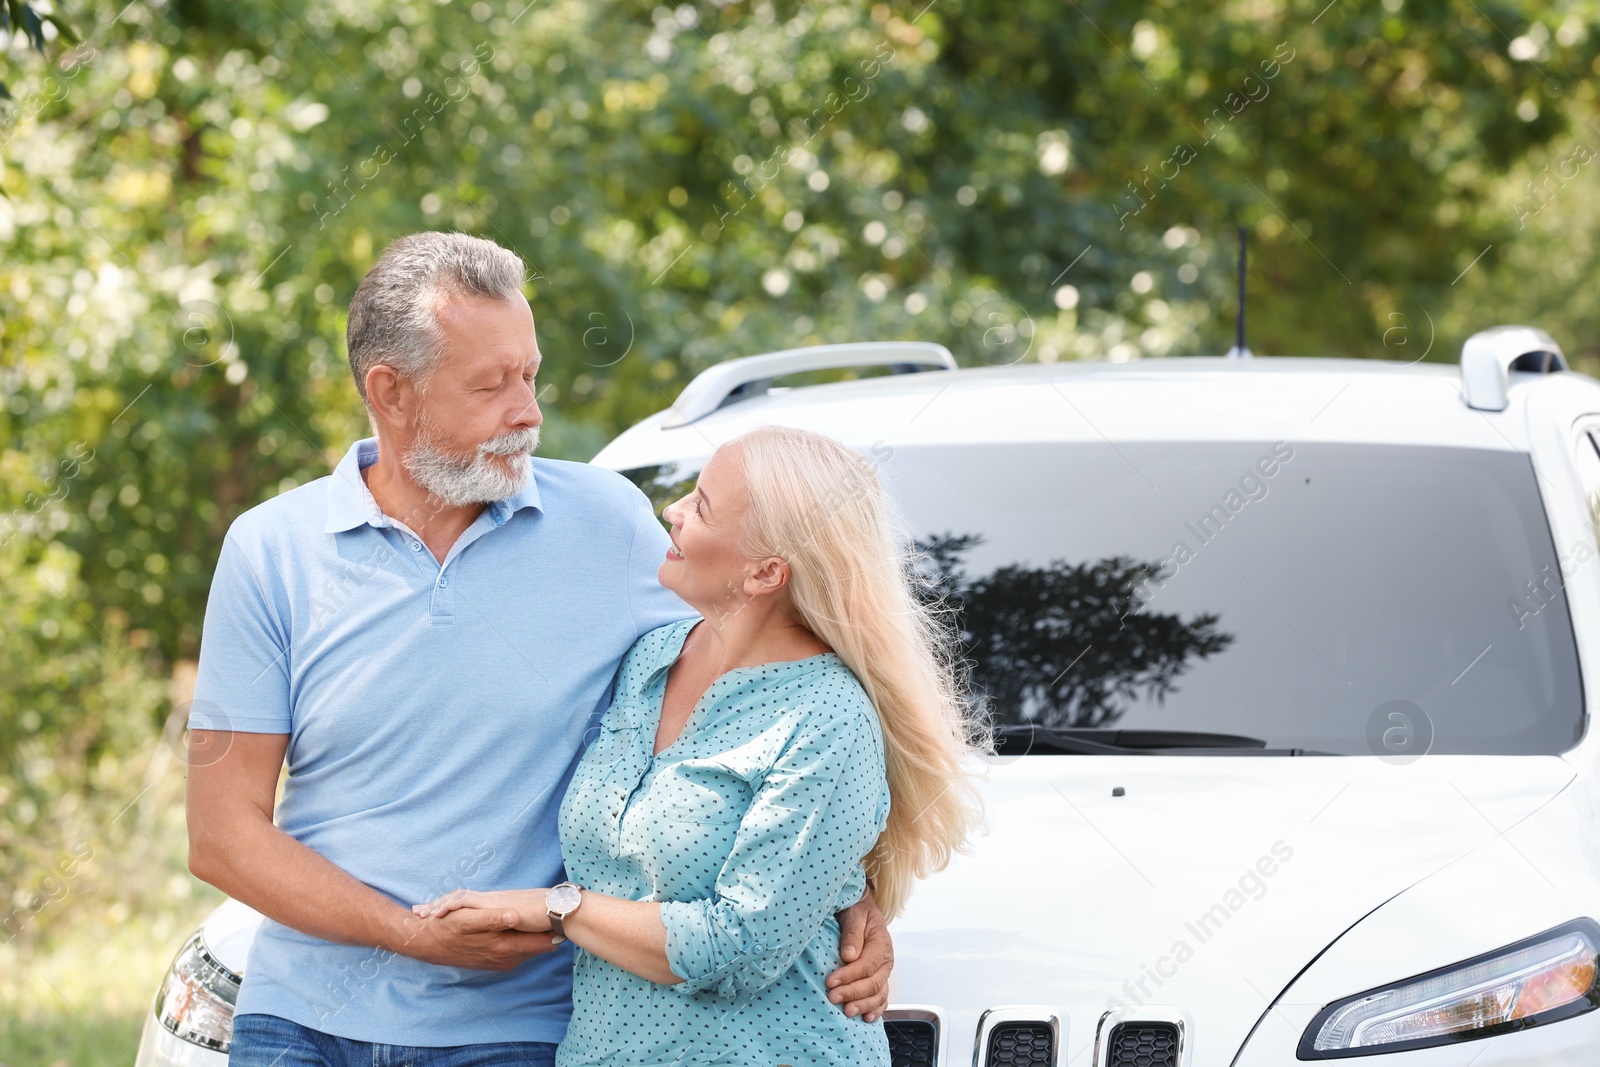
[227,1014,555,1067]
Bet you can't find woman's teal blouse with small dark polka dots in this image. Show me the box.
[557,619,890,1067]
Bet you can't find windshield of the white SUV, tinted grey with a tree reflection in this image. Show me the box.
[626,442,1584,758]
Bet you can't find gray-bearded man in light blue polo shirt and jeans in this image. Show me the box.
[187,234,891,1067]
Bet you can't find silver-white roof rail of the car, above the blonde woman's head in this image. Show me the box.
[661,341,955,429]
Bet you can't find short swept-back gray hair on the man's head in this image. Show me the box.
[344,230,523,406]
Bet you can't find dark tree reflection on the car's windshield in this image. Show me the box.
[917,533,1234,729]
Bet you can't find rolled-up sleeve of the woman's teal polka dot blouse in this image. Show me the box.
[661,694,888,1000]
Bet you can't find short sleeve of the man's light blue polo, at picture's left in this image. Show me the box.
[189,531,290,734]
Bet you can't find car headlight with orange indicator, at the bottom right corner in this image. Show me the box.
[1296,918,1600,1059]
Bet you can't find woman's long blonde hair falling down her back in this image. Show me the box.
[730,426,987,918]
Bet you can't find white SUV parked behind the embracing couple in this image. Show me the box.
[139,326,1600,1067]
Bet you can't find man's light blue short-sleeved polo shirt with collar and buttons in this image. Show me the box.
[189,438,693,1046]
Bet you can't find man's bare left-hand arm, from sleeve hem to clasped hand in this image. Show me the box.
[186,729,550,971]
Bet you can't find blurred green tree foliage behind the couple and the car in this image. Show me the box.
[0,0,1600,1036]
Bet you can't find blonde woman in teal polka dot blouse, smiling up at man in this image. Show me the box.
[418,427,978,1067]
